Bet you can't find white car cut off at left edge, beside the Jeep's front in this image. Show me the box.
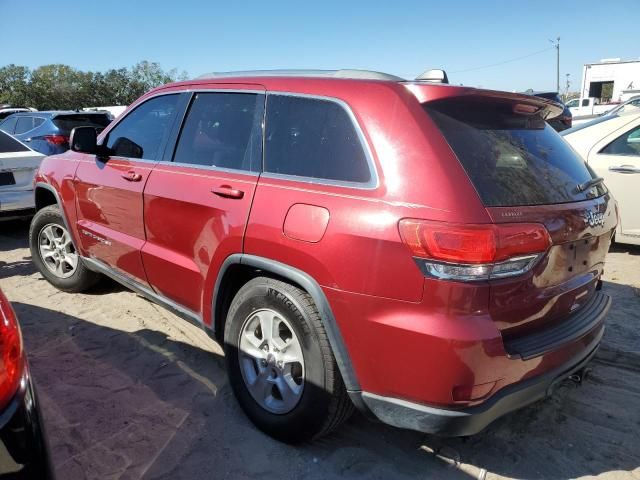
[0,131,44,218]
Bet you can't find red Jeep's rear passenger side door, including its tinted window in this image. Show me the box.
[142,85,265,318]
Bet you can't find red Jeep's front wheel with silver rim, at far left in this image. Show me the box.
[29,205,101,292]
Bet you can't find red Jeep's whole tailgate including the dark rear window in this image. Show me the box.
[425,95,616,338]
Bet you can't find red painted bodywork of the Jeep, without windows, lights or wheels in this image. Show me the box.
[37,77,617,432]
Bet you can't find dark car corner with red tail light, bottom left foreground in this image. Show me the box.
[0,290,53,480]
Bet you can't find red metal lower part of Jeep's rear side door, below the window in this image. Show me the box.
[142,164,258,318]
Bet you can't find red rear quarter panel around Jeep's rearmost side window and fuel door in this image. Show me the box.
[244,80,489,302]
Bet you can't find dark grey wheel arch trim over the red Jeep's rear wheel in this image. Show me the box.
[211,254,361,392]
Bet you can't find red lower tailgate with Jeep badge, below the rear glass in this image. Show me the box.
[487,194,617,340]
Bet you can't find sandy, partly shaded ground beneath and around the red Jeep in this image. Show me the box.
[0,218,640,480]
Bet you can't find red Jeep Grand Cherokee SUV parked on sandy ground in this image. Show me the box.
[29,70,617,442]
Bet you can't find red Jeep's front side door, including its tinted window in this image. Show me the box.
[75,94,181,284]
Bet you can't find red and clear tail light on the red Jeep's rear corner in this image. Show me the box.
[399,219,551,281]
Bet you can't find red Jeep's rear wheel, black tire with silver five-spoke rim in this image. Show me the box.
[224,277,354,443]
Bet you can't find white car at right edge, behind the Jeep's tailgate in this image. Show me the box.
[562,112,640,245]
